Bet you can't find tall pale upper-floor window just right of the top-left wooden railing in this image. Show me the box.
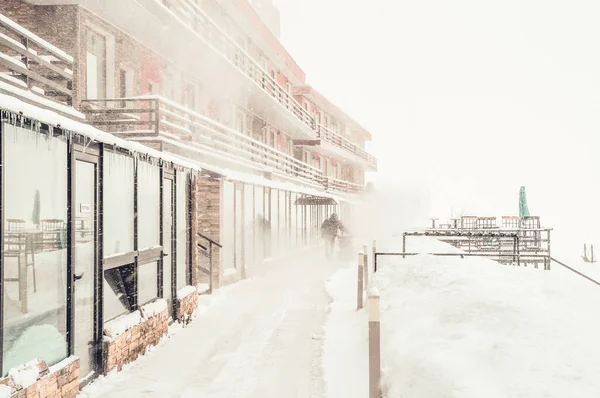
[86,29,107,99]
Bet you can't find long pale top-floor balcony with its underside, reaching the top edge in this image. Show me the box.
[29,0,316,139]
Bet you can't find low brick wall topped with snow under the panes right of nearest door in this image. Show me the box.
[102,300,169,373]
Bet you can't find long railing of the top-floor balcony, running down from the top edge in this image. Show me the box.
[155,0,315,130]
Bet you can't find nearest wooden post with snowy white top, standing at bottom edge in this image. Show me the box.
[367,289,381,398]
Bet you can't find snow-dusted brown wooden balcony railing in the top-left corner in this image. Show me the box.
[0,14,73,105]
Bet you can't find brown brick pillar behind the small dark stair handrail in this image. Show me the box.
[192,177,221,288]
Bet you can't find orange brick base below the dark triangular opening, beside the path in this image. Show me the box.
[102,308,169,374]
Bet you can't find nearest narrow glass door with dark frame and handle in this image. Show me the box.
[73,160,98,379]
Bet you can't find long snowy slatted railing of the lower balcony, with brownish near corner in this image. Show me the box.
[83,96,325,186]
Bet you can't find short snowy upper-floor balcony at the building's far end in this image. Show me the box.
[317,124,377,171]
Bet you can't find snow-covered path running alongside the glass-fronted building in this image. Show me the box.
[80,255,340,398]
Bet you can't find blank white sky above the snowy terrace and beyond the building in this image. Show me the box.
[274,0,600,239]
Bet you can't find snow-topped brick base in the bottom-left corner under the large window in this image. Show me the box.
[0,357,79,398]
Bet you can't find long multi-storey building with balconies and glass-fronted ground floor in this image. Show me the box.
[0,0,377,397]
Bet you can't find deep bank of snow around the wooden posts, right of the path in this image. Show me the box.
[324,238,600,398]
